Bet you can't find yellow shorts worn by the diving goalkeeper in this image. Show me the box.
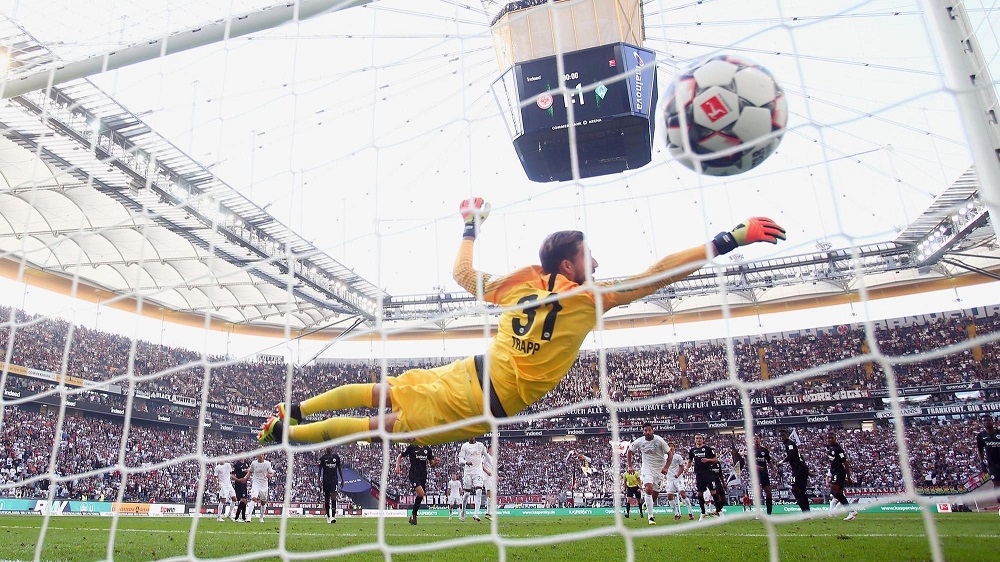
[386,357,491,445]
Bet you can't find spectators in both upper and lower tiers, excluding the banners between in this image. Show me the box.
[0,307,1000,501]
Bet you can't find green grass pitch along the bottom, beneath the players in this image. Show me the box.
[0,513,1000,562]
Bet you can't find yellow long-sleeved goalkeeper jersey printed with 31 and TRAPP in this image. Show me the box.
[454,239,706,416]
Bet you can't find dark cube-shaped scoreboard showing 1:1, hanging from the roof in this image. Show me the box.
[493,43,657,182]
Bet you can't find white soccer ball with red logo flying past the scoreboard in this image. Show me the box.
[663,55,788,176]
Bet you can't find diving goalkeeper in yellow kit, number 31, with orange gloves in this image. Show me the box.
[257,198,785,445]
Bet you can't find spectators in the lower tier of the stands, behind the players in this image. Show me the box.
[0,406,980,502]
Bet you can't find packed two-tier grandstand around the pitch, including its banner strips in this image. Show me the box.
[0,306,1000,505]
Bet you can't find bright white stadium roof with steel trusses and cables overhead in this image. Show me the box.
[0,0,1000,330]
